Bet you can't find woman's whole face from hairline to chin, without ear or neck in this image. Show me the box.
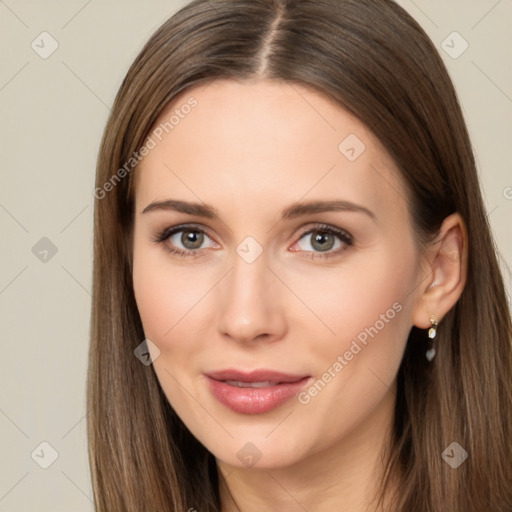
[133,80,425,468]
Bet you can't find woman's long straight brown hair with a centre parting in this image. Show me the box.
[88,0,512,512]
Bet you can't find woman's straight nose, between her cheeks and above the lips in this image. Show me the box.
[217,251,286,344]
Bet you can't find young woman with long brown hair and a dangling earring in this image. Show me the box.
[88,0,512,512]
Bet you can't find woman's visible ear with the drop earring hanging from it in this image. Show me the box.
[412,213,468,329]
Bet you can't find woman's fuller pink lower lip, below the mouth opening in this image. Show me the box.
[207,376,310,414]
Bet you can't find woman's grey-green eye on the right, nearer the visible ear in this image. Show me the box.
[291,224,353,258]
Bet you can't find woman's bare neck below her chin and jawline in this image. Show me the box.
[217,389,396,512]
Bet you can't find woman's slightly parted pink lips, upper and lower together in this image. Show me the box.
[205,369,311,414]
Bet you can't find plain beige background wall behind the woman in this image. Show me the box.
[0,0,512,512]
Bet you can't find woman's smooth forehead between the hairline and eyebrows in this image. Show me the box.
[135,80,405,220]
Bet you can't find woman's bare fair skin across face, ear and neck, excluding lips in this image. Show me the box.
[133,79,467,512]
